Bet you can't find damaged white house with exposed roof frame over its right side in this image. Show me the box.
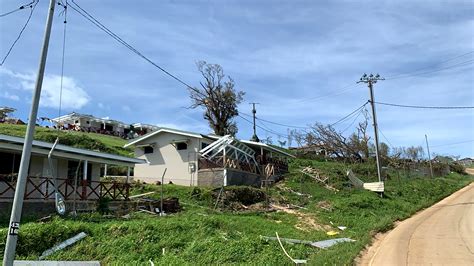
[125,128,293,186]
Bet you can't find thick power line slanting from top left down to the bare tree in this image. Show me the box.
[70,0,193,89]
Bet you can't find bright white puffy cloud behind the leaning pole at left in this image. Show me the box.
[0,69,90,110]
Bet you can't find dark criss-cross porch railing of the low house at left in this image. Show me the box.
[0,176,130,200]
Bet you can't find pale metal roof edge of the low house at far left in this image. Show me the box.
[0,134,146,164]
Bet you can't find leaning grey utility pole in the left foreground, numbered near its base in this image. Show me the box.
[3,0,56,266]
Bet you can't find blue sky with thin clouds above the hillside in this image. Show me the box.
[0,0,474,156]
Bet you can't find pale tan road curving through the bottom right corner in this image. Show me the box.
[358,183,474,265]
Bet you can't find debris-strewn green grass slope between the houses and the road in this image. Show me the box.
[0,160,473,265]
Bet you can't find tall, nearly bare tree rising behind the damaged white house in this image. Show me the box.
[188,61,245,136]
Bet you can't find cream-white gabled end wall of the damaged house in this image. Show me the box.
[134,132,205,186]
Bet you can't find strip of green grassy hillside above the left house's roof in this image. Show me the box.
[0,124,133,157]
